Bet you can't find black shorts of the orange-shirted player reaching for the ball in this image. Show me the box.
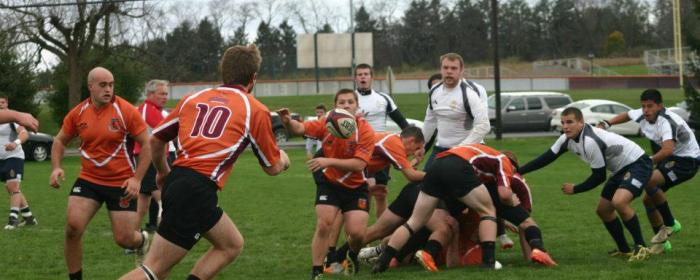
[314,171,369,213]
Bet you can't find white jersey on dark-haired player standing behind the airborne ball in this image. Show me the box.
[355,89,398,132]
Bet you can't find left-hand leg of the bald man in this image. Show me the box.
[63,195,101,279]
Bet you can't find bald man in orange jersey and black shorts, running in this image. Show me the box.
[49,67,151,279]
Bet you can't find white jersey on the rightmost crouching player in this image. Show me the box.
[627,109,700,158]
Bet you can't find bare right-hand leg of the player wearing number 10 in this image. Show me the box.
[190,213,243,279]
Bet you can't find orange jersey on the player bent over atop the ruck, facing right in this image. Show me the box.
[435,144,515,188]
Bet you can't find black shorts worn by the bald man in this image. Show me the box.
[70,178,136,212]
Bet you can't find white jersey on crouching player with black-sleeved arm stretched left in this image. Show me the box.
[551,124,644,174]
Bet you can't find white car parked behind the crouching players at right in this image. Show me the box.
[551,99,639,135]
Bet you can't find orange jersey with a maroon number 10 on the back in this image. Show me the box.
[153,86,280,189]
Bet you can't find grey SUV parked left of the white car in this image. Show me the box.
[488,92,573,131]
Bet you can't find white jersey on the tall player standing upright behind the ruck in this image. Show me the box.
[423,81,491,148]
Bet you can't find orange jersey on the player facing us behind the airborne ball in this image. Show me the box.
[304,117,374,189]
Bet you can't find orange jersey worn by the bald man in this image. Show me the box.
[61,96,146,187]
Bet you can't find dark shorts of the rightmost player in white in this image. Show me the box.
[656,156,700,192]
